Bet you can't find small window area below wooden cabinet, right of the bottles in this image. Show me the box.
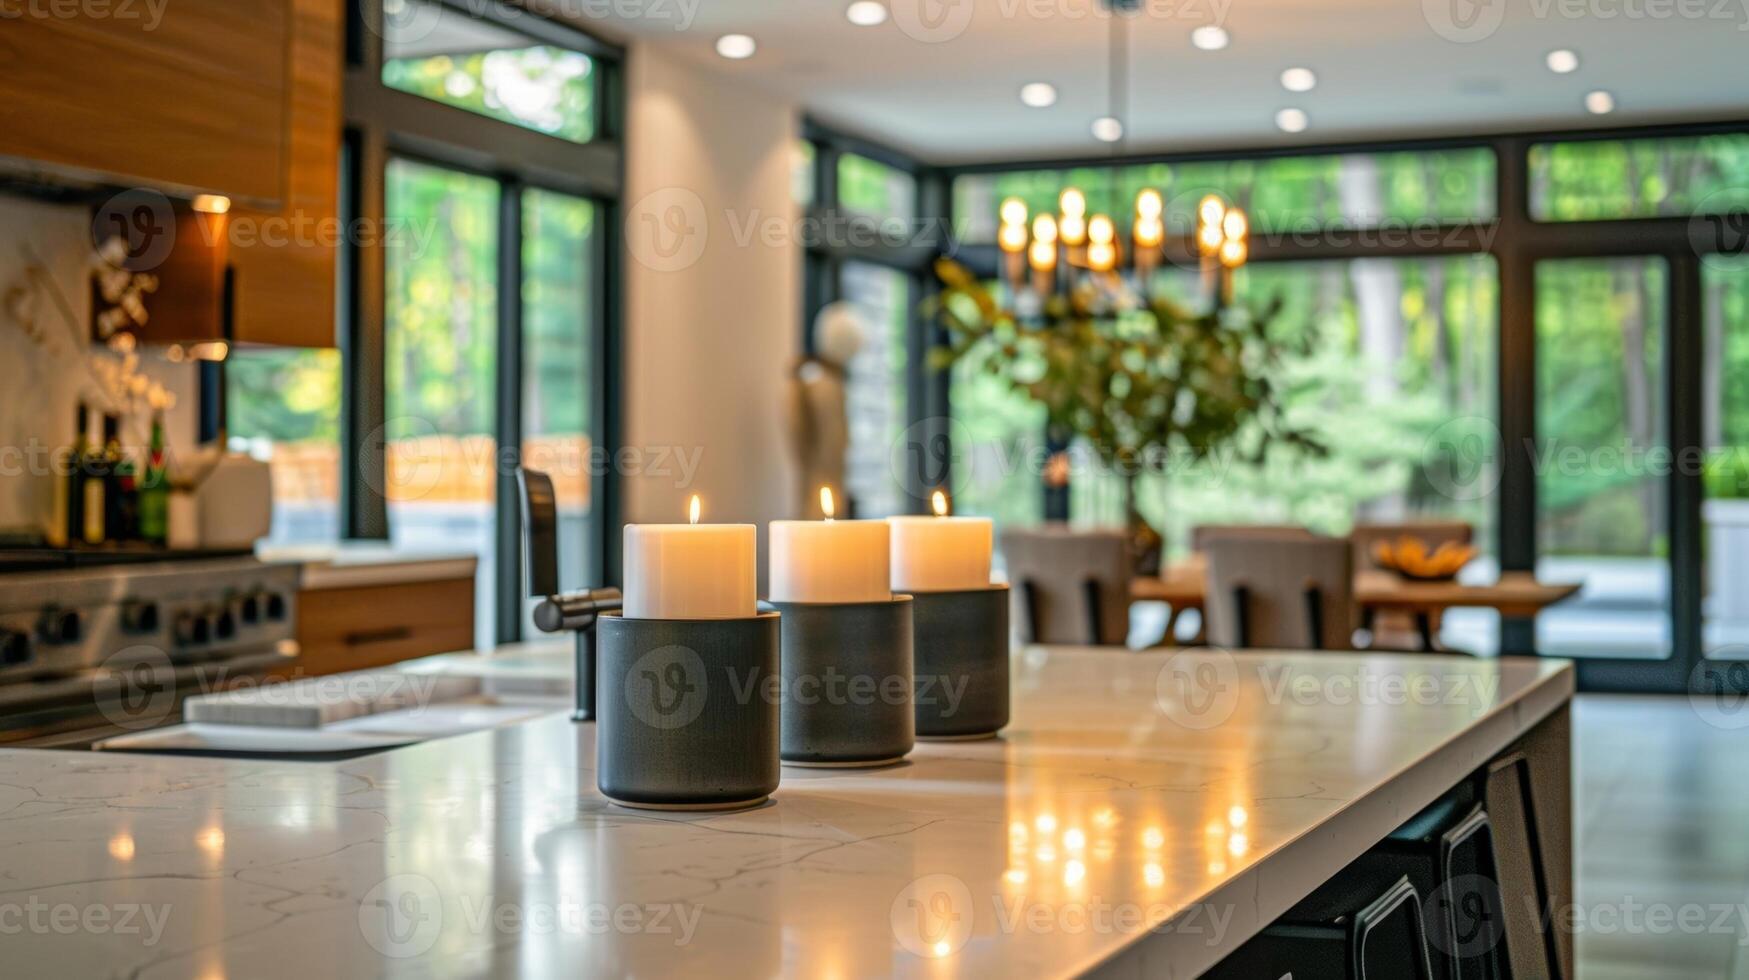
[224,350,341,546]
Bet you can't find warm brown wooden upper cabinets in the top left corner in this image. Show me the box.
[0,0,345,347]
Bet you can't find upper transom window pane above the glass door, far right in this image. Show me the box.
[1530,133,1749,221]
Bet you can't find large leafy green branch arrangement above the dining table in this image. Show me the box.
[925,259,1324,560]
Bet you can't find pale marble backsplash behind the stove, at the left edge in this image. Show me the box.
[0,196,198,532]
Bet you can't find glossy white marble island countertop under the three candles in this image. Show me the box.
[0,648,1572,980]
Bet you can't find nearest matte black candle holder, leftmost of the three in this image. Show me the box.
[595,613,780,810]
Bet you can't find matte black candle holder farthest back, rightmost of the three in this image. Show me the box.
[911,585,1009,742]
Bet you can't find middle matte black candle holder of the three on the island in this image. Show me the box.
[768,595,916,768]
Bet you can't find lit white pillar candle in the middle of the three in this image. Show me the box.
[771,488,892,602]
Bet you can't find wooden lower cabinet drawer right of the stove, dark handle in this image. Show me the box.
[285,576,474,677]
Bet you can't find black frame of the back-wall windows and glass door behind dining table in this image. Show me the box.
[937,119,1749,693]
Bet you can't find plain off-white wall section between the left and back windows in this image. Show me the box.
[624,44,801,574]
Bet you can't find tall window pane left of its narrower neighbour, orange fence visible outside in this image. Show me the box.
[383,159,500,649]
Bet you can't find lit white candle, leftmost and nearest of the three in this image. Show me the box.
[624,499,759,620]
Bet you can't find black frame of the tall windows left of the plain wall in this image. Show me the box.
[339,0,624,644]
